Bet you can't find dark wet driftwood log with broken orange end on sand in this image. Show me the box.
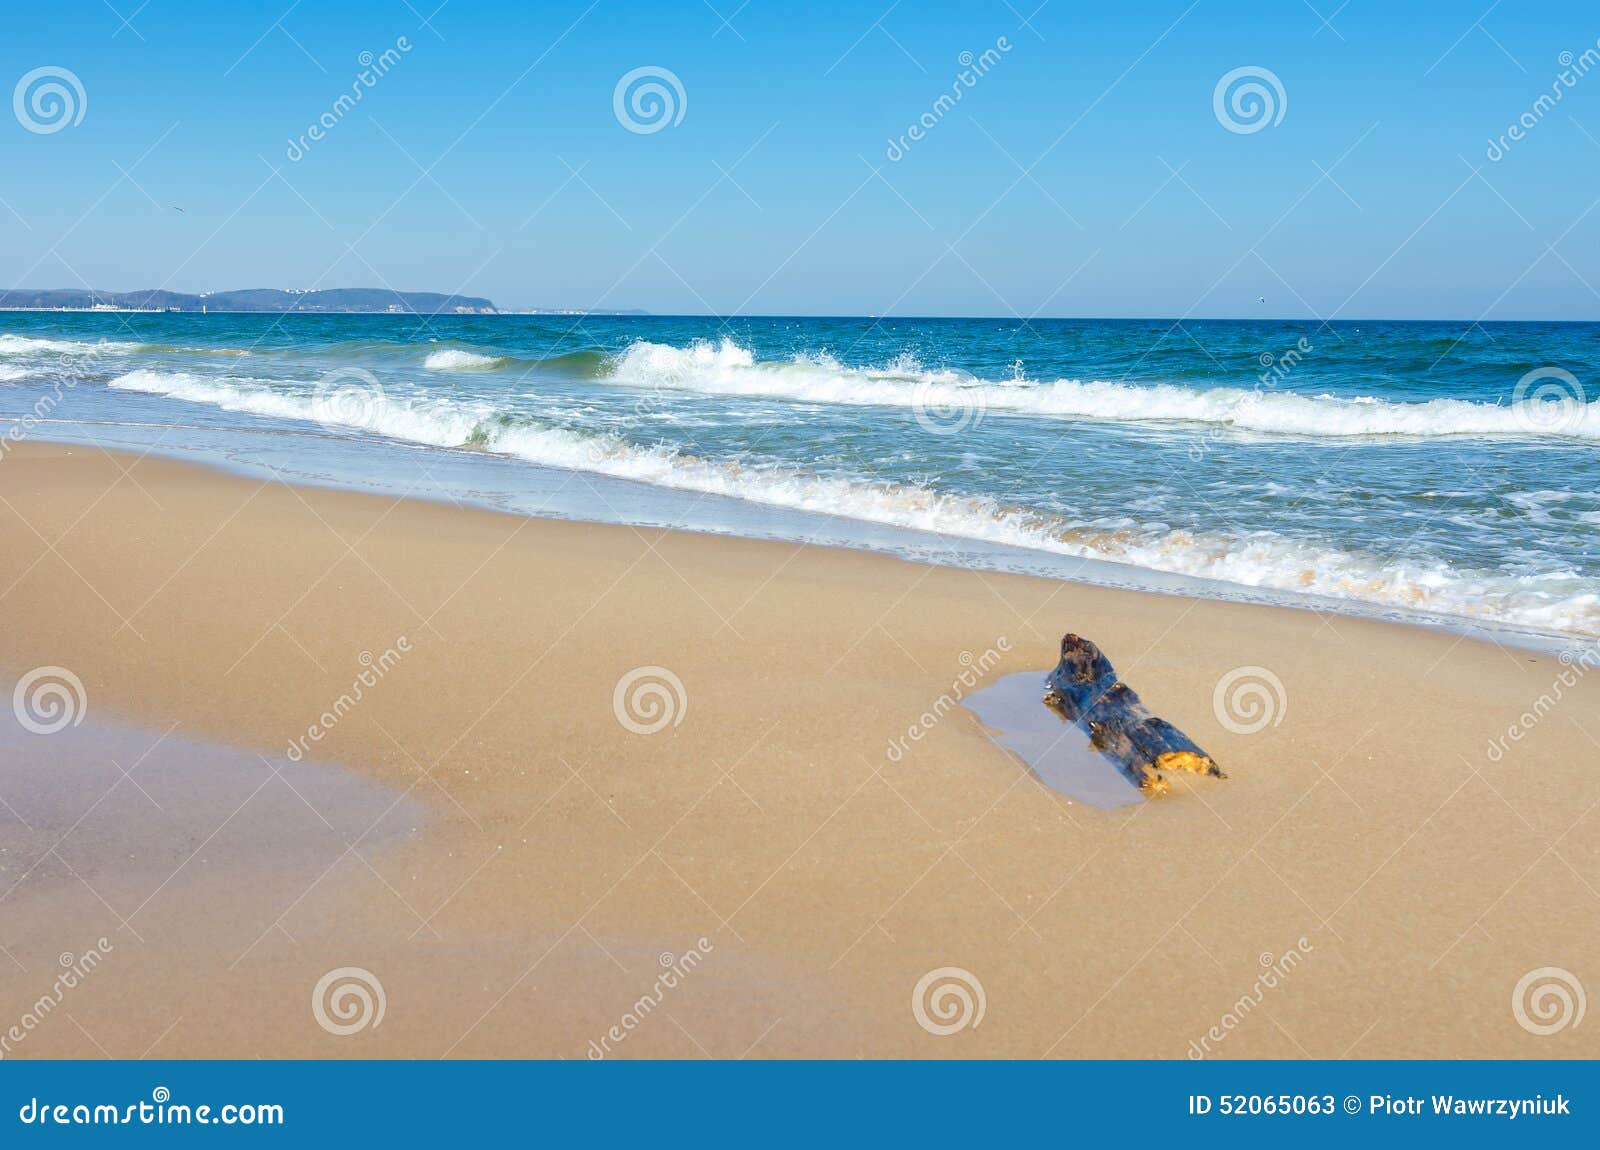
[1045,633,1227,797]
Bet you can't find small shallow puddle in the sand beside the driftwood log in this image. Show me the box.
[962,670,1144,808]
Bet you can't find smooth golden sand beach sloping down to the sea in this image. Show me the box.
[0,445,1600,1057]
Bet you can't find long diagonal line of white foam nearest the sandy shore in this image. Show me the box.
[96,371,1600,633]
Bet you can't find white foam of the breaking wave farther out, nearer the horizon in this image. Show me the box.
[610,339,1600,440]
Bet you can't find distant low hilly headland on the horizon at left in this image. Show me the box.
[0,288,499,315]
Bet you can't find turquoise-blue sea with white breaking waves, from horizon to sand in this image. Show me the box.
[0,312,1600,635]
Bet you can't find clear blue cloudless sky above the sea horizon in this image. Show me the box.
[0,0,1600,318]
